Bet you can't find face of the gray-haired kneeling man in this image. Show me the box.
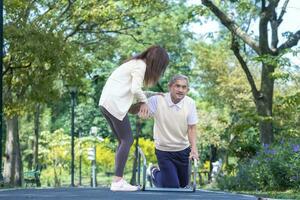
[169,79,189,104]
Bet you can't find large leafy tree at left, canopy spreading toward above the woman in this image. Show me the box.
[4,0,189,185]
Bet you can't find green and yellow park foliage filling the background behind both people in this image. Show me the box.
[3,0,300,197]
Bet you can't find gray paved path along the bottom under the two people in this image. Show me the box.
[0,188,257,200]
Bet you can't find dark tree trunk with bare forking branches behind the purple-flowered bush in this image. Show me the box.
[202,0,300,144]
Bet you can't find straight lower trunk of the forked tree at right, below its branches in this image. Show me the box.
[256,64,274,144]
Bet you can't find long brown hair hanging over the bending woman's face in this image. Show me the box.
[130,45,169,86]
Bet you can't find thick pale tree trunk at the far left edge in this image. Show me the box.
[3,116,23,186]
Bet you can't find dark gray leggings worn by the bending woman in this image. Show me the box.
[100,106,133,177]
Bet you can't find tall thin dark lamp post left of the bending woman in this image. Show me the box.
[70,87,77,187]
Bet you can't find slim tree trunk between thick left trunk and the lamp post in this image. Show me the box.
[33,104,41,167]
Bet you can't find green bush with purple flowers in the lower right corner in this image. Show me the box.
[218,139,300,191]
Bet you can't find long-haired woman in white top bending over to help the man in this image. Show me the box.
[99,45,169,191]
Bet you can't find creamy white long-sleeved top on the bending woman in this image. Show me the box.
[99,59,147,121]
